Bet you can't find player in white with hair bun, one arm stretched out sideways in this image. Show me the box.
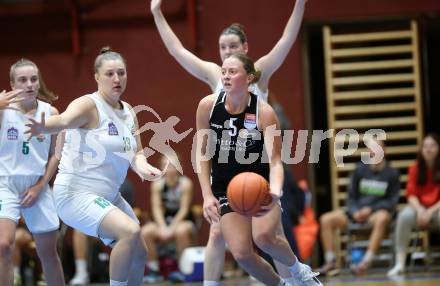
[28,47,160,286]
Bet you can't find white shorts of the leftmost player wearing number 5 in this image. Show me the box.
[0,176,60,234]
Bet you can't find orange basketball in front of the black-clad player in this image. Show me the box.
[227,172,272,216]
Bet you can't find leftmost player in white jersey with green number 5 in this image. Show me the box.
[0,59,64,286]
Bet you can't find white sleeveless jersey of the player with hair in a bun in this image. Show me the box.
[55,92,137,193]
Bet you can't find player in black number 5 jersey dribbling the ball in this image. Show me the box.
[196,54,322,286]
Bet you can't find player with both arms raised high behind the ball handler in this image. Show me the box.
[151,0,307,286]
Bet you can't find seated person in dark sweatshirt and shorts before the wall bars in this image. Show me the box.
[318,141,400,275]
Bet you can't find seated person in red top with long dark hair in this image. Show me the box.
[387,134,440,276]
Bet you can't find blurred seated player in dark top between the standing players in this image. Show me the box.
[142,157,195,283]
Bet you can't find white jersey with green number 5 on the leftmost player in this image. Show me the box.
[0,100,51,176]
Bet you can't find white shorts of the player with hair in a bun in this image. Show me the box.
[54,184,139,245]
